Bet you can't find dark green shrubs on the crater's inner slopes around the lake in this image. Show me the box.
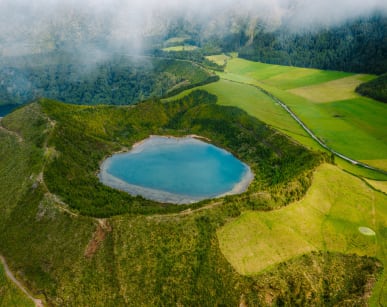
[36,91,327,217]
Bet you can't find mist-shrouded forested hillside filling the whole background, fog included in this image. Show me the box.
[0,0,387,105]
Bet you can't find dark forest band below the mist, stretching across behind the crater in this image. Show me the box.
[0,15,387,111]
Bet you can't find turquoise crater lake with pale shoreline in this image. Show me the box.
[100,137,252,203]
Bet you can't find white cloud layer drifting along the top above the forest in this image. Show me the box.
[0,0,387,54]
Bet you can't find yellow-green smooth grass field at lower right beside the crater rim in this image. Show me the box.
[218,165,387,304]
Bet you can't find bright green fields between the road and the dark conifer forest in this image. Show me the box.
[212,59,387,173]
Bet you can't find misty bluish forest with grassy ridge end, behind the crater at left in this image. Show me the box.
[0,57,214,105]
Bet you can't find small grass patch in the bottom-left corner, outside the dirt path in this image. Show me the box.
[0,262,35,307]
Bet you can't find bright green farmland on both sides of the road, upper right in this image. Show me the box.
[166,55,387,180]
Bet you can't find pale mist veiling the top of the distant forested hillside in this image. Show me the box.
[0,0,387,57]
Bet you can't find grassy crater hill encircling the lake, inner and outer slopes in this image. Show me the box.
[0,93,379,306]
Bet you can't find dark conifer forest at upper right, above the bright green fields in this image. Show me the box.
[239,16,387,74]
